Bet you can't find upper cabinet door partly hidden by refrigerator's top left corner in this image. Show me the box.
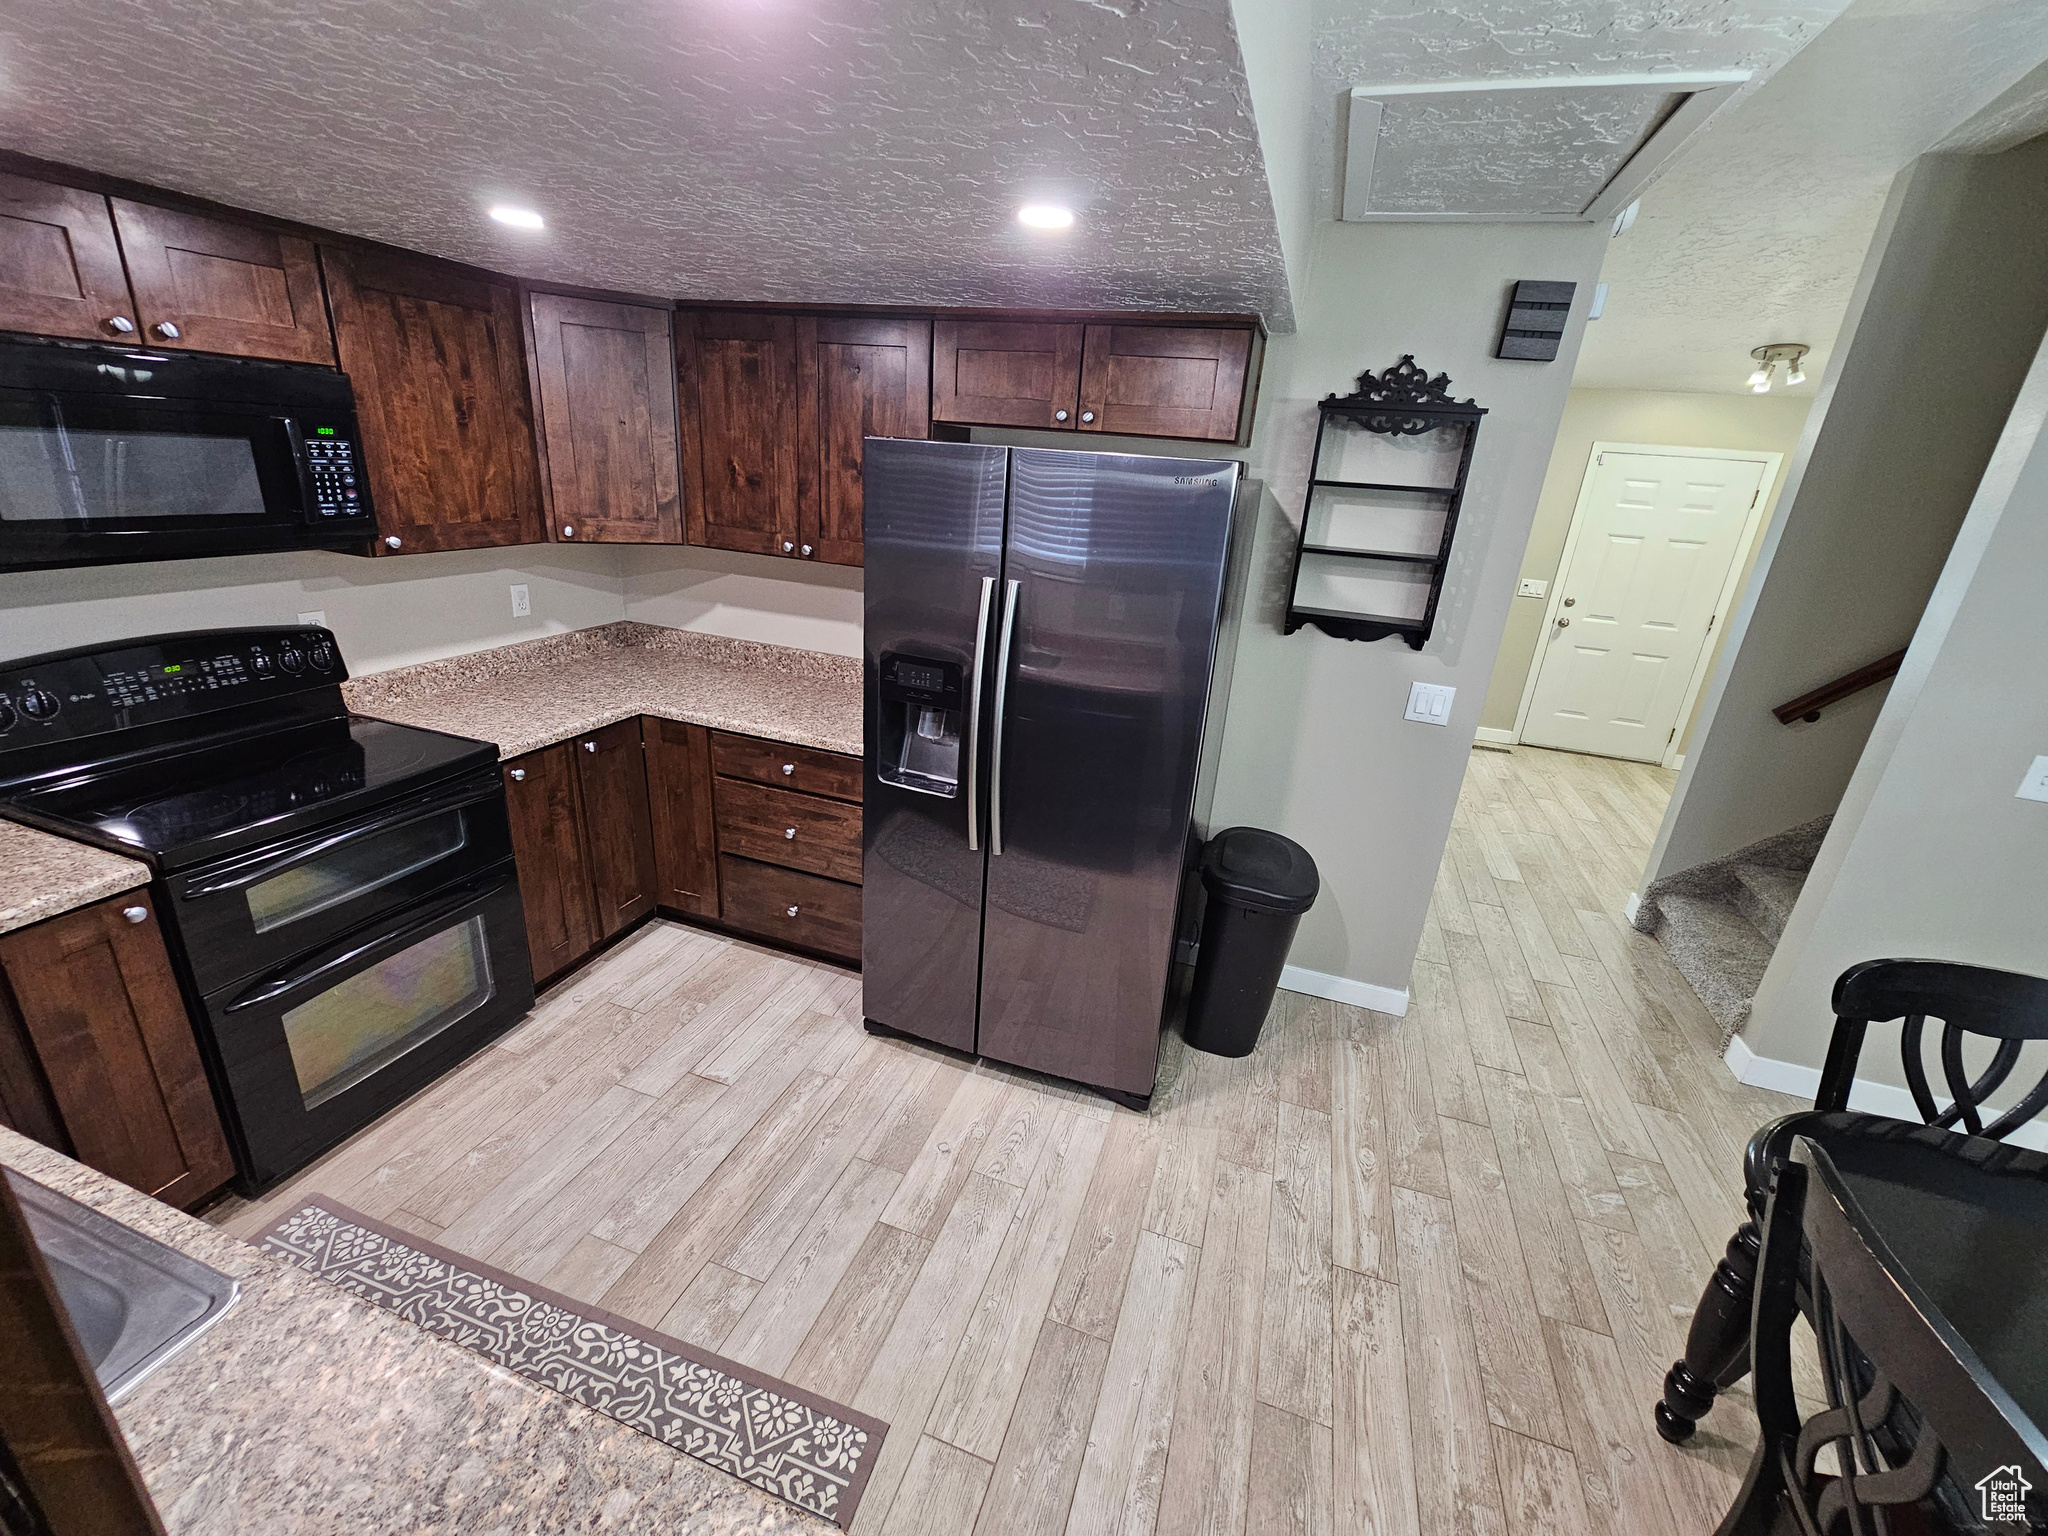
[797,317,932,565]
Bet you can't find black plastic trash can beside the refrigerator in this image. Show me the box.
[1186,827,1321,1057]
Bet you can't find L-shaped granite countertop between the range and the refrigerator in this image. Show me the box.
[342,621,862,758]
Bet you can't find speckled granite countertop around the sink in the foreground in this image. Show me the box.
[0,1128,838,1536]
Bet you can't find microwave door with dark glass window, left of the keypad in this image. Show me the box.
[0,389,303,532]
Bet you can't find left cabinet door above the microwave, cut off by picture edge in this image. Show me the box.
[0,174,135,342]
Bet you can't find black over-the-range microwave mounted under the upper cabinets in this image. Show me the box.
[0,338,373,571]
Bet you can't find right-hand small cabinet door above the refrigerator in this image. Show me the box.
[1081,326,1251,442]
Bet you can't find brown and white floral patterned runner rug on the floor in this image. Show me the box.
[260,1196,889,1528]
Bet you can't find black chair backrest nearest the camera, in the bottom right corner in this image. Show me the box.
[1751,1137,2048,1536]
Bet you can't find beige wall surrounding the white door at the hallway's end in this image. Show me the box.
[1479,389,1812,752]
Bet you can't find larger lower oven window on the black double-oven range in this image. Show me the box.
[283,918,494,1110]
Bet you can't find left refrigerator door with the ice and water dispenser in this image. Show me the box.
[860,438,1006,1051]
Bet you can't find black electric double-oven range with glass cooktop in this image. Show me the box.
[0,629,532,1192]
